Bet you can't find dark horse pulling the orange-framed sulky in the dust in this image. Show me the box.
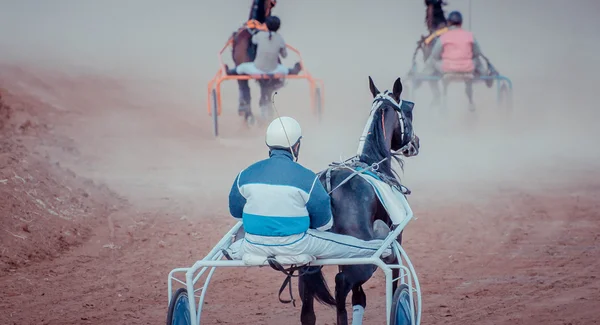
[231,0,281,123]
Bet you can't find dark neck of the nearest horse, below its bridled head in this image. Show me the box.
[358,100,404,185]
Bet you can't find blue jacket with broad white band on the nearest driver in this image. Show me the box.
[229,150,333,237]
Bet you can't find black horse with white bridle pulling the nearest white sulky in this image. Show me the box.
[298,77,419,325]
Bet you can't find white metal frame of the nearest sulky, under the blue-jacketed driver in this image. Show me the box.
[167,200,422,325]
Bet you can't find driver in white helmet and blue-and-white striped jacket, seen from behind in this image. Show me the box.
[224,117,392,259]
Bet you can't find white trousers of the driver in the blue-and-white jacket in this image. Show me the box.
[227,229,392,259]
